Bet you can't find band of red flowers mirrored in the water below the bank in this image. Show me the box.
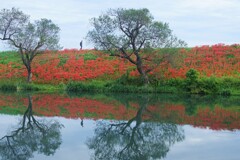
[0,94,240,130]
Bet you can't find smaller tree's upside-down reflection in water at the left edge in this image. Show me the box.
[0,96,62,160]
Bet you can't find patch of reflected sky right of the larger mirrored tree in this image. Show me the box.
[166,126,240,160]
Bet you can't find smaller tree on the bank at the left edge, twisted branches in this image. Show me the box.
[0,8,60,82]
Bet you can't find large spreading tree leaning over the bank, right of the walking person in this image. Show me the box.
[87,8,186,83]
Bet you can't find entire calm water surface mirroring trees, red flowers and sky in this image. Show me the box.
[0,93,240,160]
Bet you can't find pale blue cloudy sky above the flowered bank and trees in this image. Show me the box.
[0,0,240,51]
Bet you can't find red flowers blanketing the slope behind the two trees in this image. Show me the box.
[0,44,240,83]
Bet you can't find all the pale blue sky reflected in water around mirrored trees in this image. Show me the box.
[0,115,240,160]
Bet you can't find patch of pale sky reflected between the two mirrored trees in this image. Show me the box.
[34,117,95,160]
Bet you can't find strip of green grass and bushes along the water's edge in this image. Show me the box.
[0,74,240,96]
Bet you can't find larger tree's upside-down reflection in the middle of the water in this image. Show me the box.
[87,94,184,160]
